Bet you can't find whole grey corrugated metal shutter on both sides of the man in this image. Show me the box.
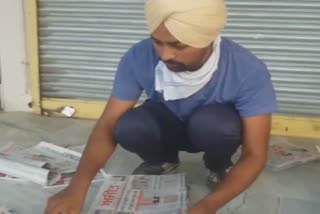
[38,0,320,115]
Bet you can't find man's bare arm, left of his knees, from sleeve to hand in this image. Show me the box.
[45,98,137,214]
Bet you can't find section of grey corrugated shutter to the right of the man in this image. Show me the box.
[225,0,320,115]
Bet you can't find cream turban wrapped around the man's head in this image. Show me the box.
[145,0,227,48]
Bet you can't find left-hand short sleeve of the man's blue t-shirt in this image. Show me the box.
[111,50,143,101]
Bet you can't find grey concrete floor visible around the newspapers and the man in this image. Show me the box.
[0,113,320,214]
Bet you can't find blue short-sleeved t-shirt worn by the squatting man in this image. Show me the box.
[112,38,277,120]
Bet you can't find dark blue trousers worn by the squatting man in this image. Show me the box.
[114,100,242,170]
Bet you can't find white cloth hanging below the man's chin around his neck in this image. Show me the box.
[155,36,221,101]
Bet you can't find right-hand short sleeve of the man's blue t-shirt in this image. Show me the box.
[235,68,277,117]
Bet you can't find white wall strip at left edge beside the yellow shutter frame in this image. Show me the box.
[0,0,31,111]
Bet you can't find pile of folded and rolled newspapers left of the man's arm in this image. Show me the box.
[0,142,104,188]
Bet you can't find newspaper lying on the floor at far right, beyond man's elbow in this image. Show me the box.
[267,142,320,171]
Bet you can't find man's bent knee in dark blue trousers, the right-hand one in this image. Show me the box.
[188,104,242,147]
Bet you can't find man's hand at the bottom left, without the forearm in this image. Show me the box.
[44,187,86,214]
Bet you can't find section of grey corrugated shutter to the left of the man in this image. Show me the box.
[38,0,148,100]
